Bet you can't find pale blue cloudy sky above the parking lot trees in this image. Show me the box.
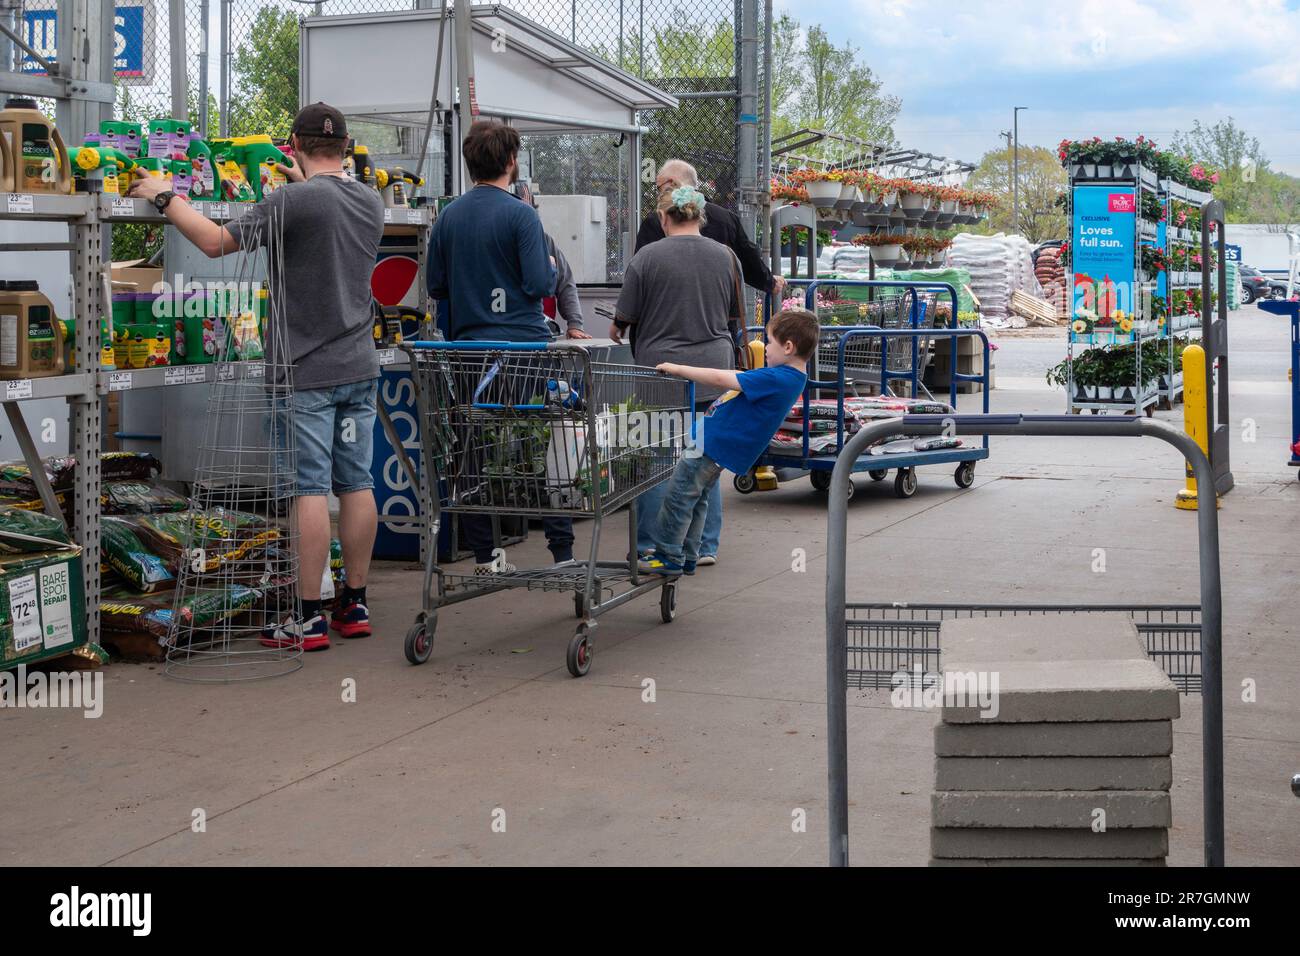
[775,0,1300,174]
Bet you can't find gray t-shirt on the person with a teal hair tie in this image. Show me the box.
[616,235,745,402]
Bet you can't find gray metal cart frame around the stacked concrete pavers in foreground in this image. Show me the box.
[826,415,1223,866]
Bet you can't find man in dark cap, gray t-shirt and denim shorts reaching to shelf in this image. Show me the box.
[130,103,384,650]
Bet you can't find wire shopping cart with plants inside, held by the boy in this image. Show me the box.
[404,342,694,676]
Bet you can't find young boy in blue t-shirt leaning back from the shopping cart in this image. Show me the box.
[641,308,819,575]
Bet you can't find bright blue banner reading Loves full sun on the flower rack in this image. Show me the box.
[1070,186,1138,319]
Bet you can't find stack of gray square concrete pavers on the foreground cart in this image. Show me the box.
[931,614,1178,866]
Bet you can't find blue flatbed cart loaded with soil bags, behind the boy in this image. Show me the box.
[733,281,991,498]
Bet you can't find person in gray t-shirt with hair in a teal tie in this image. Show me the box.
[610,186,745,563]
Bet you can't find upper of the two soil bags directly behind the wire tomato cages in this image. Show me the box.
[135,507,281,574]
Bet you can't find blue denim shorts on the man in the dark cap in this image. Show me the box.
[284,378,378,497]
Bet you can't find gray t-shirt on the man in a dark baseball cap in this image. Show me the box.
[226,176,384,390]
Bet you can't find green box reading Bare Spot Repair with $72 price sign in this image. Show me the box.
[0,545,86,670]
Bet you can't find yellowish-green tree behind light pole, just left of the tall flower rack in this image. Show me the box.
[966,146,1069,242]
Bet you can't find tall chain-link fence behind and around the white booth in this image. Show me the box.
[45,0,763,277]
